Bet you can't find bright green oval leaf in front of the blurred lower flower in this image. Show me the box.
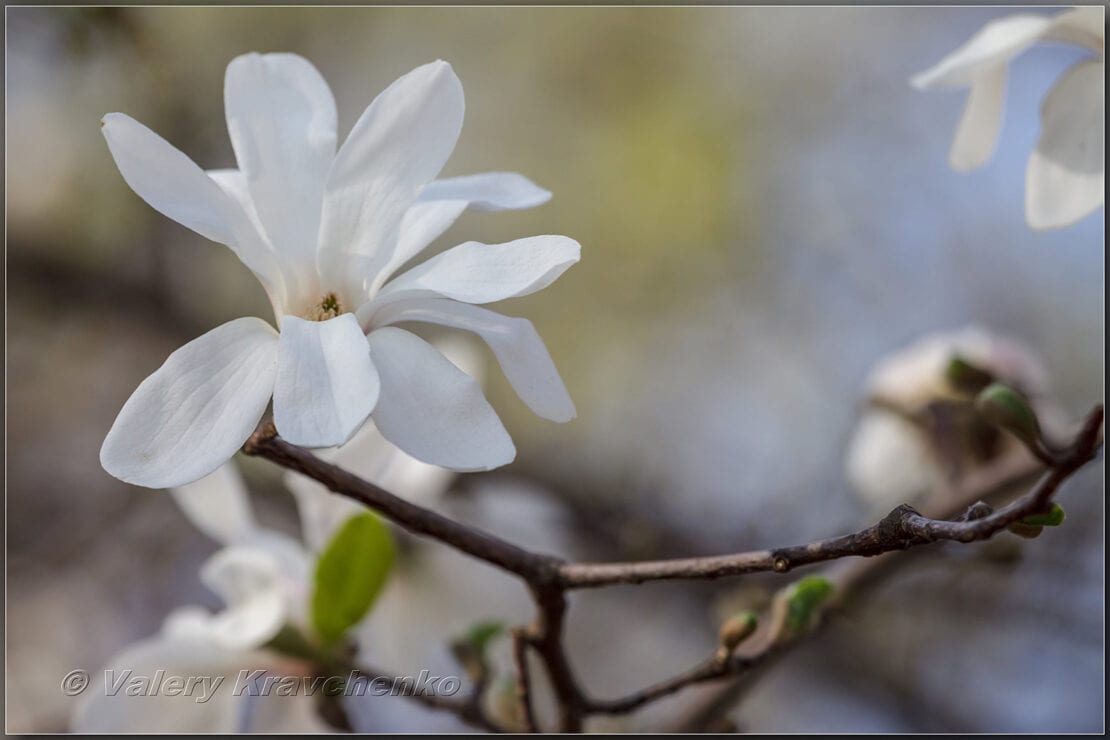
[312,511,393,645]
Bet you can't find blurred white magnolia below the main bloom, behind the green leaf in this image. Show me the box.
[73,406,457,733]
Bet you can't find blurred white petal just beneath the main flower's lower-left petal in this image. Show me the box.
[170,462,255,545]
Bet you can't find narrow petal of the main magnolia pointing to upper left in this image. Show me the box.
[100,113,282,293]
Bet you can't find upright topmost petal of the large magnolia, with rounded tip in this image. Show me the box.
[224,53,335,267]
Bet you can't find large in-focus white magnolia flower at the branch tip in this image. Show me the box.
[101,53,579,488]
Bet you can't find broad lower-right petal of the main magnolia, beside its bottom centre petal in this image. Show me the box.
[369,327,516,470]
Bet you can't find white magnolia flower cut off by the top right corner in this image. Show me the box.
[912,7,1106,229]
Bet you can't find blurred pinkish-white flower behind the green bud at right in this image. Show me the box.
[846,326,1058,514]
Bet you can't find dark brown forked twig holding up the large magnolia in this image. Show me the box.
[243,406,1103,732]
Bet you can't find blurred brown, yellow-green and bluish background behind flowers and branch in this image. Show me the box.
[6,7,1104,732]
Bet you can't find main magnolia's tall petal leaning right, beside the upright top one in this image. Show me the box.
[317,61,464,281]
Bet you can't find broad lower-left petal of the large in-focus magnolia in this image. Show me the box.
[100,317,278,488]
